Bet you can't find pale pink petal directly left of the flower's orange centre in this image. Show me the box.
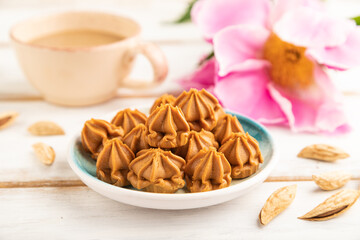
[213,25,270,76]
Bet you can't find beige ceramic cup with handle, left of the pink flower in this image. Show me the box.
[10,12,168,106]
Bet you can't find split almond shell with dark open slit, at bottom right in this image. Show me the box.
[299,189,360,221]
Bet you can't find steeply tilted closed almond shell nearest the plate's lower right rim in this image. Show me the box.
[259,185,297,225]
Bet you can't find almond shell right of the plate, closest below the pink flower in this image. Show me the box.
[298,144,350,162]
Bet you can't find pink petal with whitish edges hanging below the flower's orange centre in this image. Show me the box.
[268,67,349,133]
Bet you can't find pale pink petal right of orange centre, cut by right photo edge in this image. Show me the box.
[307,27,360,70]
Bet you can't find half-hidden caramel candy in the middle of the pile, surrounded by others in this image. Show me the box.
[174,129,219,161]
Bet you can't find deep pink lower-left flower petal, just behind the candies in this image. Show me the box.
[214,69,286,124]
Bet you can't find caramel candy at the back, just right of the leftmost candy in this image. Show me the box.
[111,108,146,136]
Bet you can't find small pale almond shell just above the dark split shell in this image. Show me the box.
[312,171,351,190]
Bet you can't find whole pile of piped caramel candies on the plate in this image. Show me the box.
[81,89,263,193]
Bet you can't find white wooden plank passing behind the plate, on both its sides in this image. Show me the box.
[0,97,360,182]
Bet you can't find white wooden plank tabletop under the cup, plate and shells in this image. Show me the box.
[0,0,360,240]
